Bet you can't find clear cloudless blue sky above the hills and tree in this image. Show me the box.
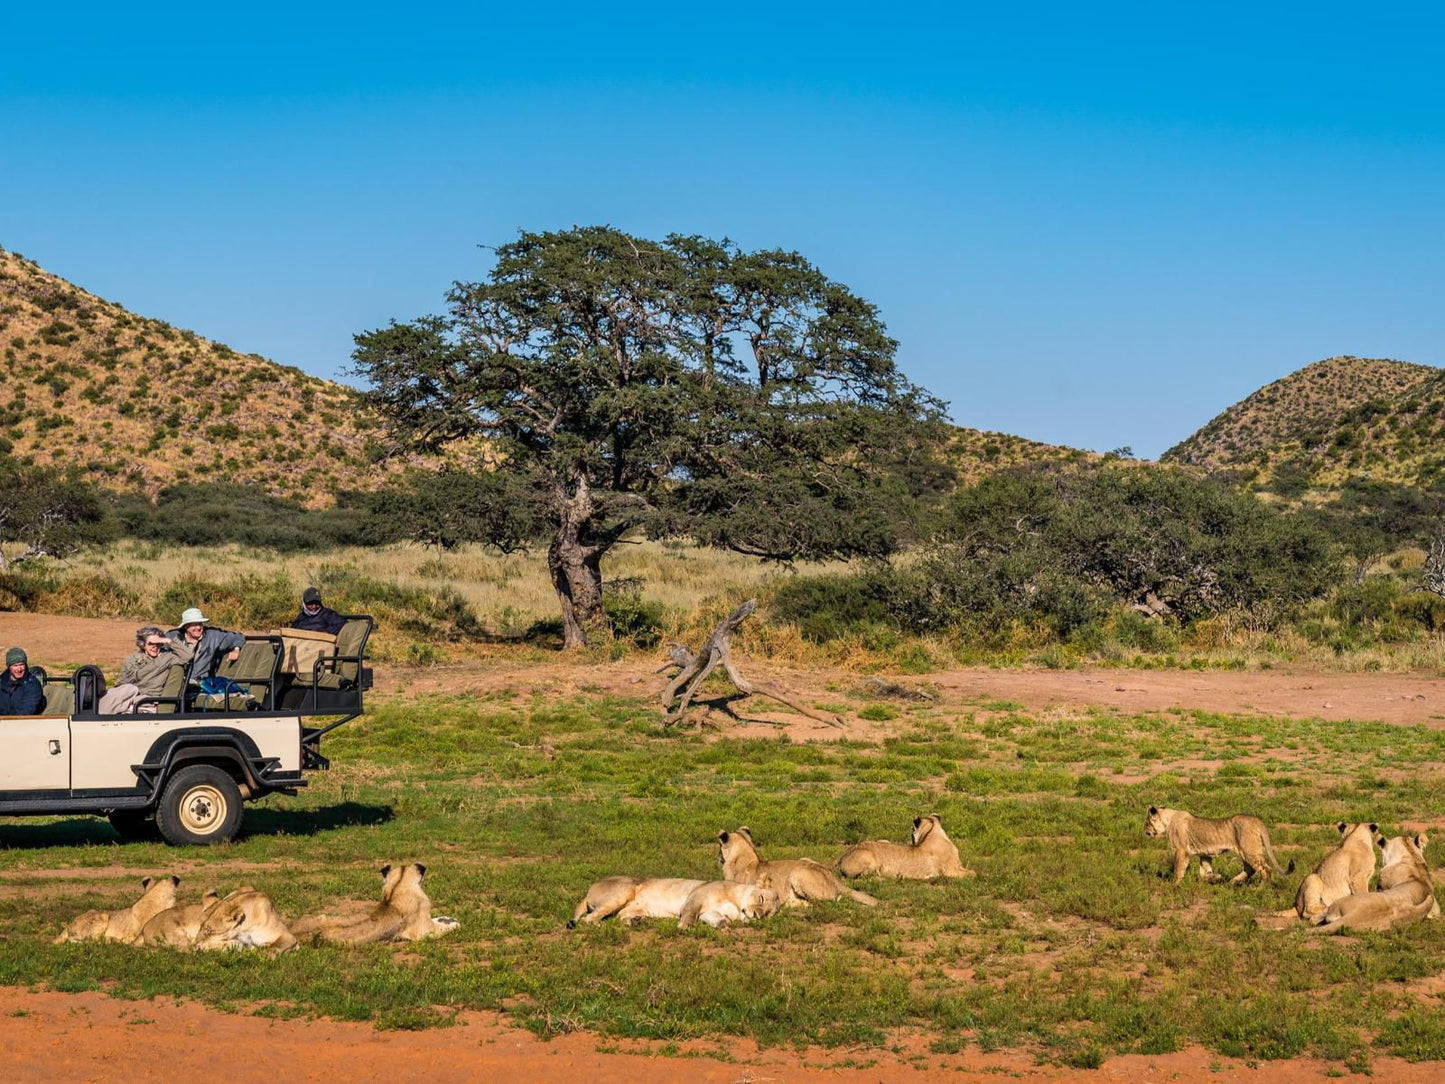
[0,3,1445,455]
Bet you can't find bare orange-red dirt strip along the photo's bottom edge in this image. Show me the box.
[0,989,1421,1084]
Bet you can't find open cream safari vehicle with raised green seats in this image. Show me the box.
[0,614,376,844]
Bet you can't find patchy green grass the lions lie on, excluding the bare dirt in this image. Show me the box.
[0,695,1445,1065]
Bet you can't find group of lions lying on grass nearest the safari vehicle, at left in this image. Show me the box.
[55,861,458,952]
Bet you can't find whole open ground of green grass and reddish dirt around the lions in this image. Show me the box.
[0,616,1445,1081]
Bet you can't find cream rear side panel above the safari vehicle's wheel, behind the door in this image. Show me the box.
[62,714,301,791]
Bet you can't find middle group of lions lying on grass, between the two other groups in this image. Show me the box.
[568,814,972,929]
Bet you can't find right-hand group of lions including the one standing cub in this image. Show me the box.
[1144,805,1441,932]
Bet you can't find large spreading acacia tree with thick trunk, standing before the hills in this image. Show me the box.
[353,227,948,648]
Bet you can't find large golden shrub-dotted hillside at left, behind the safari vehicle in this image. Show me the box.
[0,250,400,506]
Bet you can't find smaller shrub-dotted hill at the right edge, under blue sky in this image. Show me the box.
[1160,357,1445,494]
